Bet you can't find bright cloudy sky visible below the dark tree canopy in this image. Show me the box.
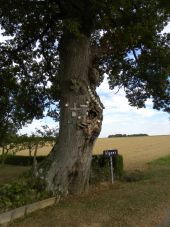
[0,24,170,137]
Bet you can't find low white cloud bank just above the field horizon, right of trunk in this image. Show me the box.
[100,112,170,137]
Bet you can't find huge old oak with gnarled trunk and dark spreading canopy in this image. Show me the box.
[0,0,170,194]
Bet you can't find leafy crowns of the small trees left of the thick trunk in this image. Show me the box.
[0,125,58,164]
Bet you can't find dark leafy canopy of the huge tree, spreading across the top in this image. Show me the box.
[0,0,170,129]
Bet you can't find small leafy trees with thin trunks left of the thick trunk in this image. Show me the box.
[0,124,58,170]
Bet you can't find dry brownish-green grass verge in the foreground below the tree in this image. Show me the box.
[10,157,170,227]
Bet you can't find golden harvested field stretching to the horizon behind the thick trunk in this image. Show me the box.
[18,135,170,170]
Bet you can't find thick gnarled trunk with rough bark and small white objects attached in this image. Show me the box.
[37,34,103,195]
